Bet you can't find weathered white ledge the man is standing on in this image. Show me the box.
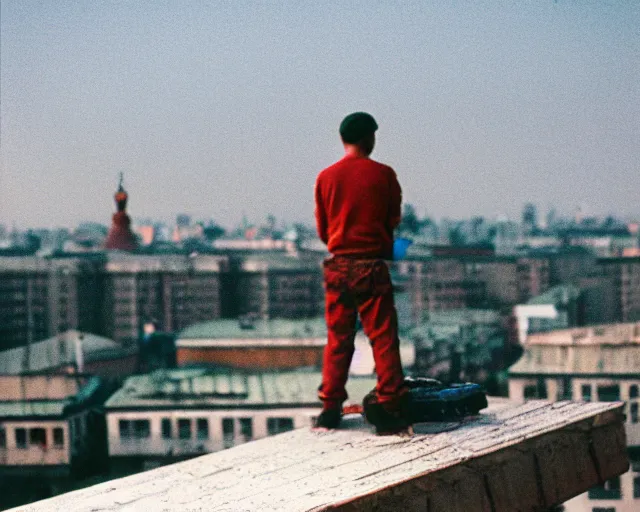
[8,401,629,512]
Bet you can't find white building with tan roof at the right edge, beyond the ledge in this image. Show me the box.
[509,323,640,512]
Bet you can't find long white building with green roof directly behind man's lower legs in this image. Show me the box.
[105,368,375,468]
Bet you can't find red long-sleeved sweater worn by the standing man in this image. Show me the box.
[315,156,402,259]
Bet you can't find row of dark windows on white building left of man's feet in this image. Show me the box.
[118,418,293,444]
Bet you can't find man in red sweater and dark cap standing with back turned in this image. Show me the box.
[315,112,409,433]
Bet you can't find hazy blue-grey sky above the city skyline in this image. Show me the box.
[0,0,640,227]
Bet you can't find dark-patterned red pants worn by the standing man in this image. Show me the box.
[318,257,406,409]
